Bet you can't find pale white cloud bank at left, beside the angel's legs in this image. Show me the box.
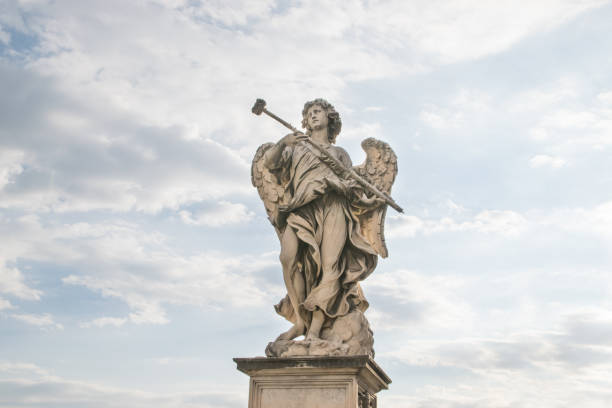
[0,216,279,324]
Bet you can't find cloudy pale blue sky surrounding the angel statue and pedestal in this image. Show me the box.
[0,0,612,408]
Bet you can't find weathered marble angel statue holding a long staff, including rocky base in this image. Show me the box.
[251,99,401,357]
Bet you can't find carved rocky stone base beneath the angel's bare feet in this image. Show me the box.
[266,310,374,357]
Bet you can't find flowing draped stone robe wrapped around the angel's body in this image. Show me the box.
[271,142,378,326]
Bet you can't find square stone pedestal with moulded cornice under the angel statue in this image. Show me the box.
[234,356,391,408]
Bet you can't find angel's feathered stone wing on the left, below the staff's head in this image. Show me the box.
[251,143,285,238]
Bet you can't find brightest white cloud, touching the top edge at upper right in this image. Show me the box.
[367,0,605,63]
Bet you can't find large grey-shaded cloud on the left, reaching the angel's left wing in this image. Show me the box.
[0,103,252,213]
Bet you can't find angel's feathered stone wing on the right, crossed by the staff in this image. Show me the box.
[353,137,397,258]
